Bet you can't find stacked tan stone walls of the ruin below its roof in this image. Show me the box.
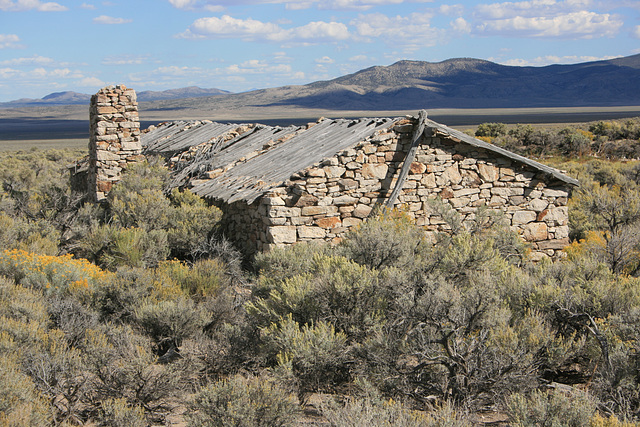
[219,119,569,260]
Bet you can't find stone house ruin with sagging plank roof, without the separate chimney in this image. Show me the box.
[85,86,578,259]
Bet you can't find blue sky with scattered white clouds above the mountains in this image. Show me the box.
[0,0,640,101]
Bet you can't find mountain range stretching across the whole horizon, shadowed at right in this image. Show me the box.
[0,54,640,111]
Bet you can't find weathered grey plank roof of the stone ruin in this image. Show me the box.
[141,114,578,203]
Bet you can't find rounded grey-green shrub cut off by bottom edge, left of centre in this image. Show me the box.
[188,375,300,427]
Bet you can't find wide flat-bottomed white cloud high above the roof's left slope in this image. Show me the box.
[179,15,350,43]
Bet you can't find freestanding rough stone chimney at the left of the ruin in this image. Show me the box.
[88,85,144,202]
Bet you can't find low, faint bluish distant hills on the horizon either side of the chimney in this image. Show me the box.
[0,86,230,108]
